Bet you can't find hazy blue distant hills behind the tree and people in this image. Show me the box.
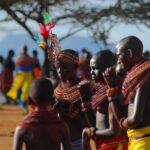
[0,33,114,63]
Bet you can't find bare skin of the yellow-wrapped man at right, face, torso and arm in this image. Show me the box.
[116,42,150,129]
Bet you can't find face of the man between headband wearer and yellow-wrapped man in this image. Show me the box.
[90,58,103,82]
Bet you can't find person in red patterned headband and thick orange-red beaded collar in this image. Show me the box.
[50,49,88,150]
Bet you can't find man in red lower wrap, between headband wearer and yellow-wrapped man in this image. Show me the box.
[82,50,126,150]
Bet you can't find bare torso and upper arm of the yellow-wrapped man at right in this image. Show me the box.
[128,80,150,128]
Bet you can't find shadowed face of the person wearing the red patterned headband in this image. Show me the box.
[55,60,76,81]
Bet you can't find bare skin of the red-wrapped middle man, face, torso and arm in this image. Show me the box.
[82,57,120,150]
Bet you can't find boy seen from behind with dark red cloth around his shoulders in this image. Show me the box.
[13,78,71,150]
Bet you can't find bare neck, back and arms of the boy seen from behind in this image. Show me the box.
[13,105,71,150]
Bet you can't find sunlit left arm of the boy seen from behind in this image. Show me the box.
[13,126,23,150]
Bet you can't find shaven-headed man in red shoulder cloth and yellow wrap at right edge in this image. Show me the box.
[113,36,150,150]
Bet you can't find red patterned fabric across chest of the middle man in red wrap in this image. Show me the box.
[91,83,107,109]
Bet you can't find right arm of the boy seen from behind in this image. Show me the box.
[62,123,72,150]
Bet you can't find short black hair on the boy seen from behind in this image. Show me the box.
[30,77,54,105]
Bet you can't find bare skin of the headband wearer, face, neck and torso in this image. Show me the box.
[54,60,88,141]
